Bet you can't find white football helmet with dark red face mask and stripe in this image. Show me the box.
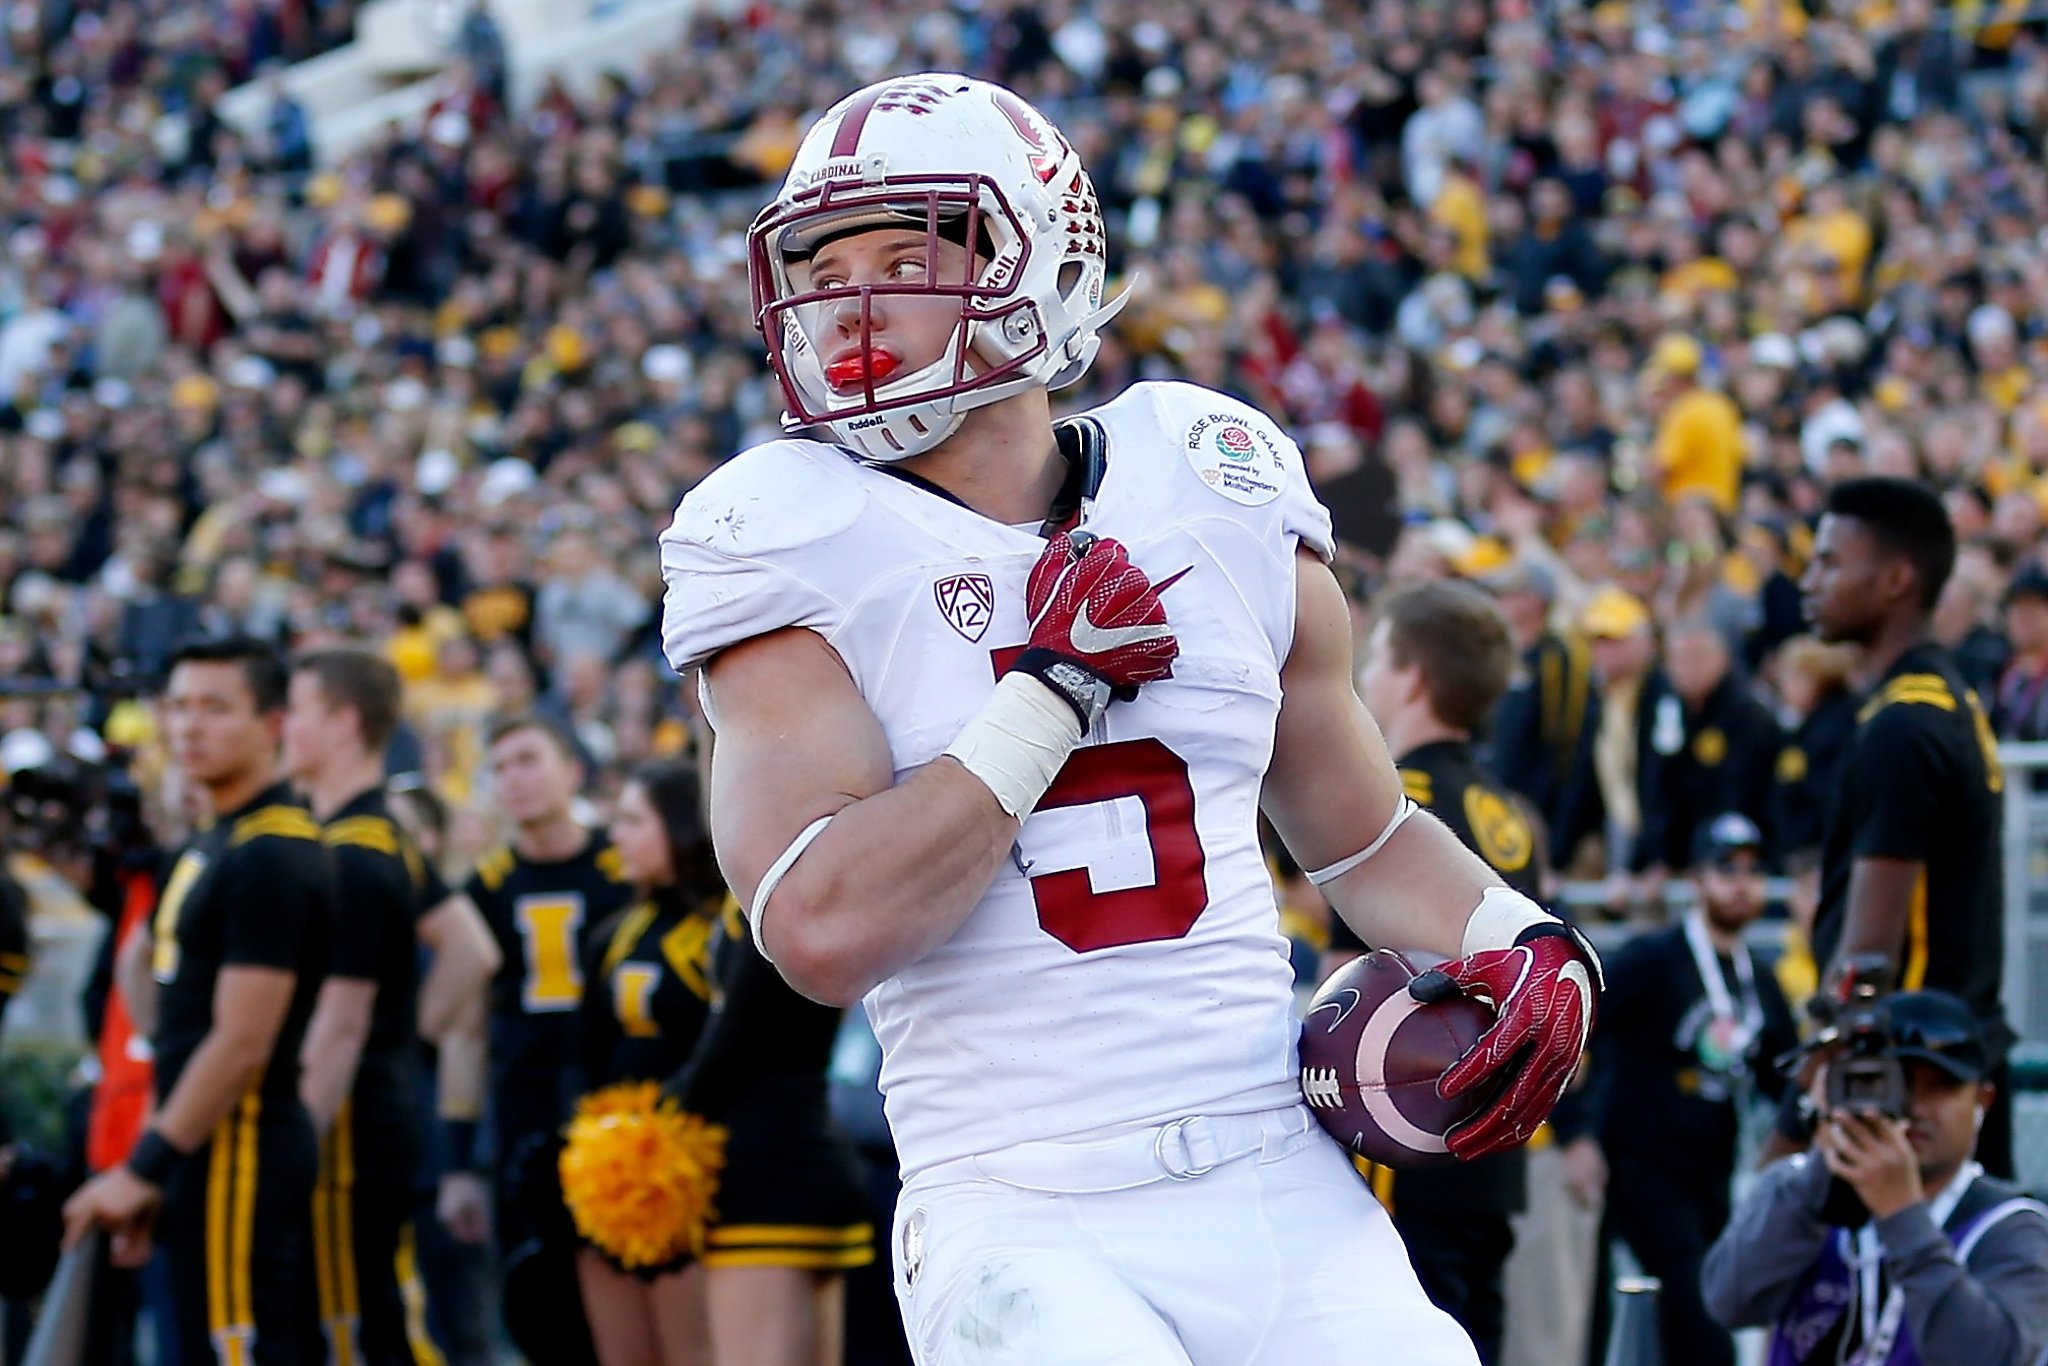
[748,72,1120,461]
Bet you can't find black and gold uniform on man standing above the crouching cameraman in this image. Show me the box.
[1812,643,2013,1176]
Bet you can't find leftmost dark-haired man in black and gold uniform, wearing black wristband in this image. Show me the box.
[66,639,334,1366]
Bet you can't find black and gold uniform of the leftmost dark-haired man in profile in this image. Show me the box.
[152,784,334,1366]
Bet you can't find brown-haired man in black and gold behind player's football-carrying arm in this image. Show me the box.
[1329,582,1542,1366]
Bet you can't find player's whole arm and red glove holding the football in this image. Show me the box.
[1264,551,1599,1159]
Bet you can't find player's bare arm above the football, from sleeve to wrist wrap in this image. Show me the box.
[1262,551,1503,958]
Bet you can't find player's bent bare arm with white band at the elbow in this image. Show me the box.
[707,631,1018,1006]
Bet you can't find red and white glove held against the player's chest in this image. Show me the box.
[1012,530,1186,731]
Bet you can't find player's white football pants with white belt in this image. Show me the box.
[891,1106,1477,1366]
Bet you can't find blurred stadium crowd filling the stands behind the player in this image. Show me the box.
[12,0,2048,1359]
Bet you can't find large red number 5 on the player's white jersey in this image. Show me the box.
[995,645,1208,954]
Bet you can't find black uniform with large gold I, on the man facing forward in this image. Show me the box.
[463,834,633,1253]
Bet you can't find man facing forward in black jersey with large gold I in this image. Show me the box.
[442,715,633,1362]
